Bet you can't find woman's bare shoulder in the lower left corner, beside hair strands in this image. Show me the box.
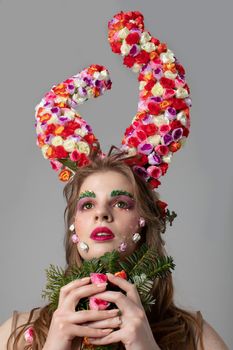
[0,310,39,350]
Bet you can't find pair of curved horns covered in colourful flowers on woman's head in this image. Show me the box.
[36,11,191,188]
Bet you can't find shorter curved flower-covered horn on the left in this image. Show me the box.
[35,65,111,181]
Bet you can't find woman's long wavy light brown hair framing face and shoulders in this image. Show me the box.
[7,154,203,350]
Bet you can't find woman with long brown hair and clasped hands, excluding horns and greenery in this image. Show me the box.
[0,155,227,350]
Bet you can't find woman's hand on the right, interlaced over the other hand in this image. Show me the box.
[85,273,160,350]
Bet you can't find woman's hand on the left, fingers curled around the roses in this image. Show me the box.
[43,277,118,350]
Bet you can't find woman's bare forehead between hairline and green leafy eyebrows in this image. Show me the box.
[80,170,133,194]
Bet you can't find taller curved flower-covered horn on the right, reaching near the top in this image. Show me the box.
[108,11,191,188]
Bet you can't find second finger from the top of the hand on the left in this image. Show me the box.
[62,283,107,311]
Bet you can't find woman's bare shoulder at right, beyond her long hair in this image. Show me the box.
[197,319,229,350]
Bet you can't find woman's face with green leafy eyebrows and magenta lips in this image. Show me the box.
[74,170,140,260]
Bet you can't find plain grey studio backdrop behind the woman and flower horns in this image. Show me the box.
[0,0,233,347]
